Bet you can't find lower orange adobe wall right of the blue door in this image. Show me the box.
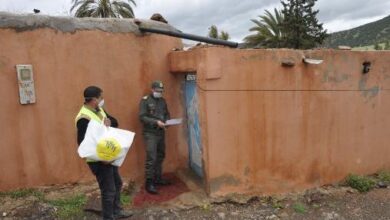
[170,47,390,195]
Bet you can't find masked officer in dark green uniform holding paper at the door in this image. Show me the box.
[139,81,170,194]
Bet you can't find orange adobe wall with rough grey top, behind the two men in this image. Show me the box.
[0,13,188,190]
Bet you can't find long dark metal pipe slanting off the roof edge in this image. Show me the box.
[138,25,238,48]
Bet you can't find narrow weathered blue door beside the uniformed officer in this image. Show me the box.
[185,74,203,177]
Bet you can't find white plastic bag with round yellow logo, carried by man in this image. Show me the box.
[77,120,135,167]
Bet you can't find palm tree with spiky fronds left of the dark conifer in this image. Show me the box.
[244,8,283,48]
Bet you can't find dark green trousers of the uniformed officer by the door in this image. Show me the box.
[144,133,165,182]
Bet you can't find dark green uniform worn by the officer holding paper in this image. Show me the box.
[139,83,170,182]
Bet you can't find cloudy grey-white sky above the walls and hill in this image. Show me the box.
[0,0,390,41]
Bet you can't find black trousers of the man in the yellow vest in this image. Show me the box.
[88,162,122,220]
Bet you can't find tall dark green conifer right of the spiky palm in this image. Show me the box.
[281,0,327,49]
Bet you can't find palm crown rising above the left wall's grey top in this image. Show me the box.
[70,0,136,18]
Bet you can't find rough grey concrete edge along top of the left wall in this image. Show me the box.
[0,12,176,34]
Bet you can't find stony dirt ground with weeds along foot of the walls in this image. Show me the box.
[0,180,390,220]
